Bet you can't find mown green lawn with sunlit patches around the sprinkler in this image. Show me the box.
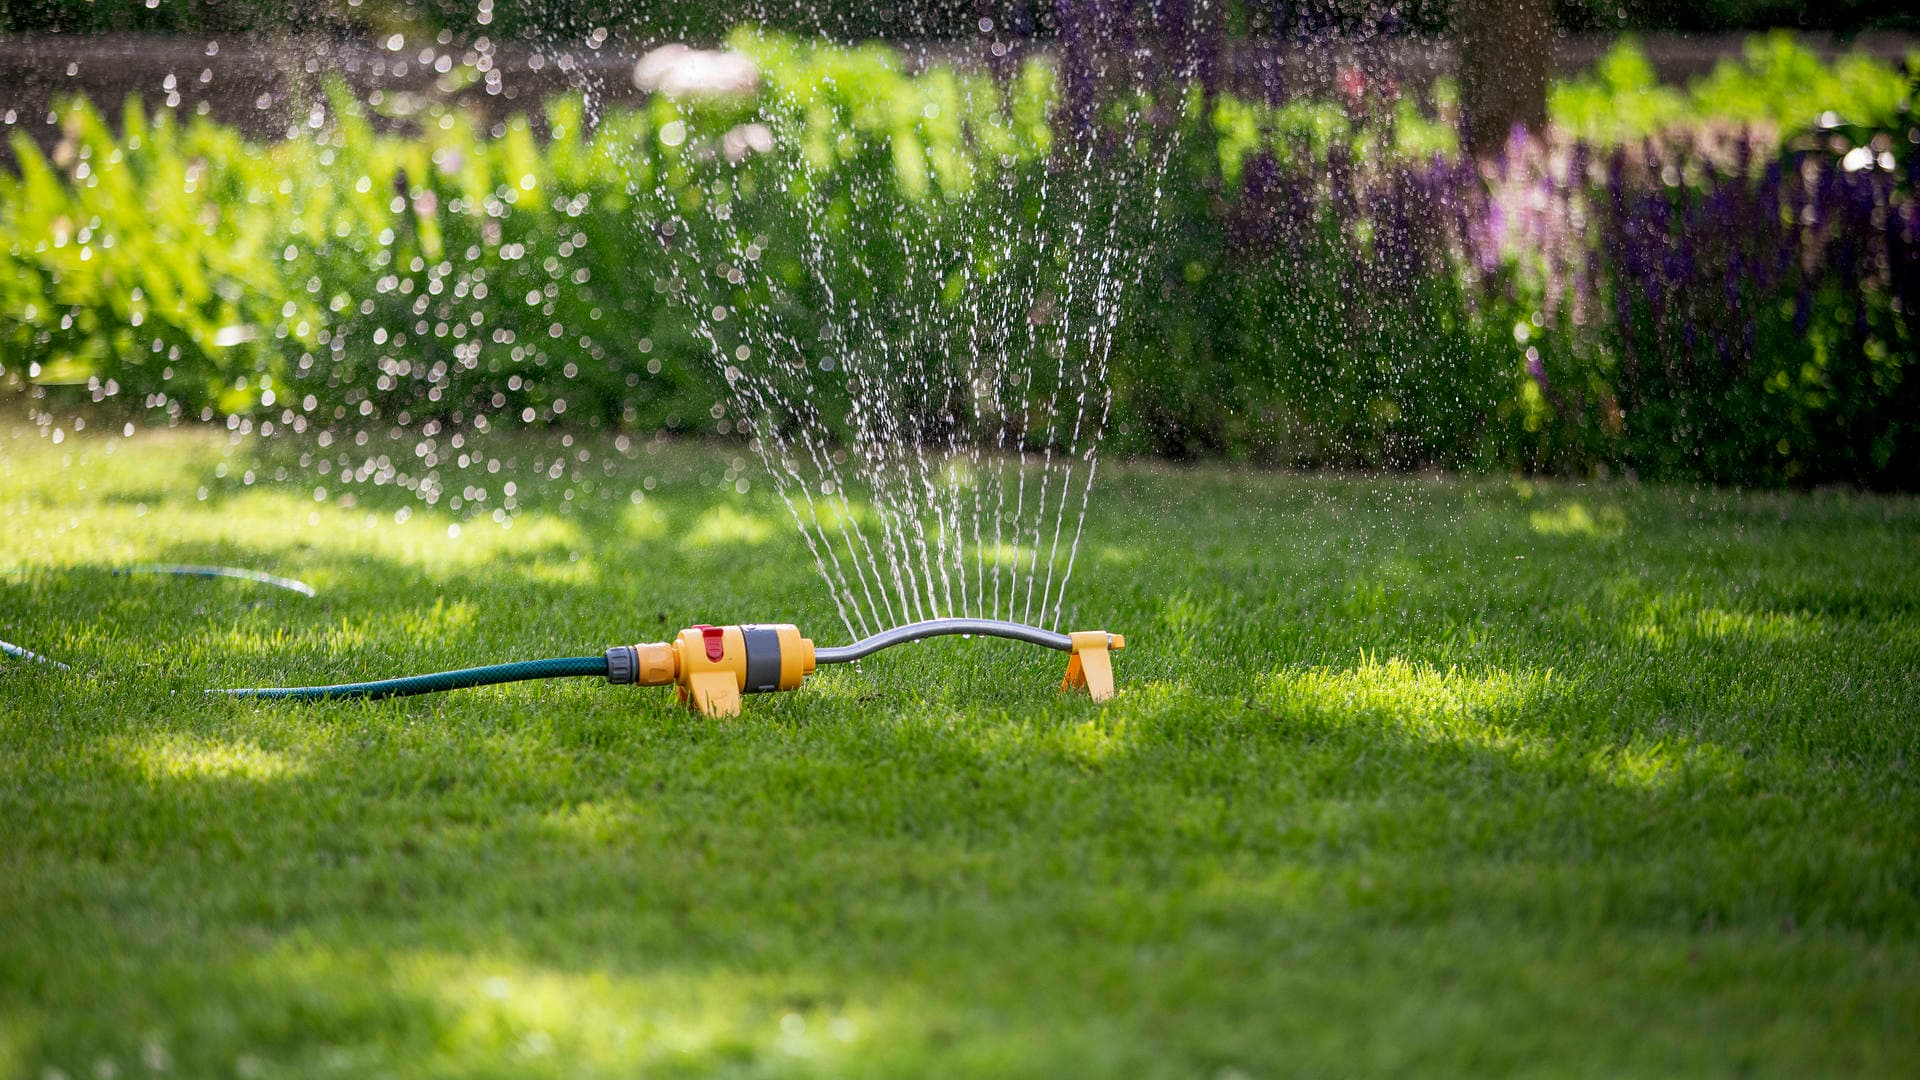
[0,420,1920,1078]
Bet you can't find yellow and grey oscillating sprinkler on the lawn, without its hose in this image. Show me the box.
[607,619,1127,717]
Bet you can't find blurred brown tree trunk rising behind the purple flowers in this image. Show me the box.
[1453,0,1553,158]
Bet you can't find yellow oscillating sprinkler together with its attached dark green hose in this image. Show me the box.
[211,619,1127,717]
